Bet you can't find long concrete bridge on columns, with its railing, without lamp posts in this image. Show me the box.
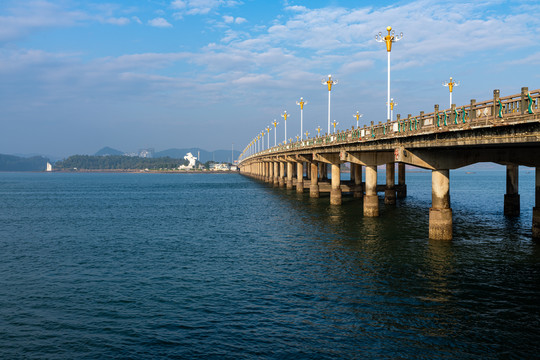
[239,87,540,240]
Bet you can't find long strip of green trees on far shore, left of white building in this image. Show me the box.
[54,155,189,170]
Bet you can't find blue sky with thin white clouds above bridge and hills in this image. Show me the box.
[0,0,540,157]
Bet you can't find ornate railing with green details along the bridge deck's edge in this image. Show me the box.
[240,88,540,161]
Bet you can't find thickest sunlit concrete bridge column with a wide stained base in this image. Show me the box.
[429,169,452,240]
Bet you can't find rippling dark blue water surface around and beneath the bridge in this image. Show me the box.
[0,168,540,359]
